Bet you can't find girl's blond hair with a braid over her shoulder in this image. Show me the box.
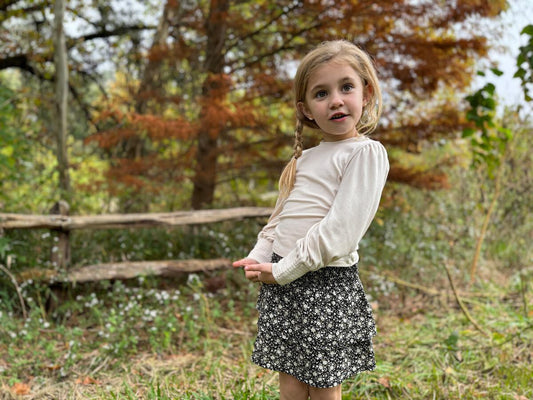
[279,40,382,199]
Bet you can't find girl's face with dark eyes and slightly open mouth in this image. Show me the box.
[298,60,366,142]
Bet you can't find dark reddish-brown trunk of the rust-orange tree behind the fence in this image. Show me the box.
[191,0,229,209]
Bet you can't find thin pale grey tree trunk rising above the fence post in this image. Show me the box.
[54,0,70,198]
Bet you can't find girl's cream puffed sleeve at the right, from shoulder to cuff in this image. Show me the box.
[272,141,389,285]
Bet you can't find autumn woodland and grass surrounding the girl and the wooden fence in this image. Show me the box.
[0,0,533,400]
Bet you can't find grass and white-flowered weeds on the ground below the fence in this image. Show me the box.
[0,260,533,400]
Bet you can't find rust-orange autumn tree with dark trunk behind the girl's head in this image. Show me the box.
[88,0,504,208]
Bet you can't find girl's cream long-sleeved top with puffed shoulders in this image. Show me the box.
[248,136,389,285]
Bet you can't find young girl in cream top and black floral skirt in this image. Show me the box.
[233,40,389,400]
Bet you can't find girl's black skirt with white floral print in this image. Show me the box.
[252,254,376,388]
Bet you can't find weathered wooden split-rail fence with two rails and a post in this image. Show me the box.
[0,202,272,282]
